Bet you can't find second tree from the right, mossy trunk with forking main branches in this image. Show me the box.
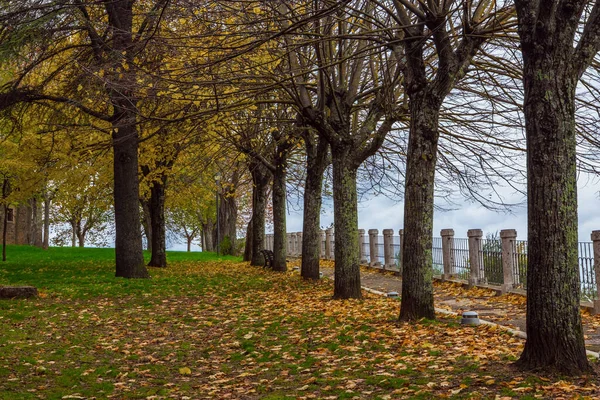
[370,0,510,320]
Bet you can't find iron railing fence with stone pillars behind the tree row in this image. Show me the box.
[266,228,600,312]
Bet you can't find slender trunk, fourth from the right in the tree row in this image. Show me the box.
[300,136,329,280]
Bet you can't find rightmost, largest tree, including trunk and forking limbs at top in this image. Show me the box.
[515,0,600,374]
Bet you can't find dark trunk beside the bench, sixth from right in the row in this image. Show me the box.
[250,162,270,266]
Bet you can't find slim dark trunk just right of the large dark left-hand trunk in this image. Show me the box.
[148,176,167,268]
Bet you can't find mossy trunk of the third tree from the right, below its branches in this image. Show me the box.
[331,146,362,299]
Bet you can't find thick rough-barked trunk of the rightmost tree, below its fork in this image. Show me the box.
[518,45,591,375]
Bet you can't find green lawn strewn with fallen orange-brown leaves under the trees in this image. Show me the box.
[0,249,600,399]
